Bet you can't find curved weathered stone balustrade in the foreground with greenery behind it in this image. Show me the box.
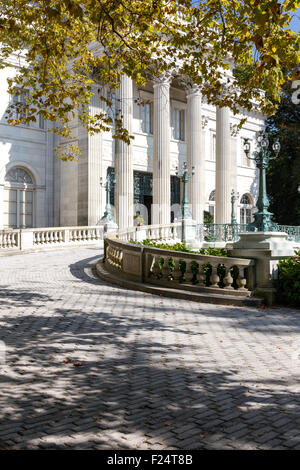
[104,236,255,297]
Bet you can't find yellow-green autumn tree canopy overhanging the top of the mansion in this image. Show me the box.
[0,0,299,158]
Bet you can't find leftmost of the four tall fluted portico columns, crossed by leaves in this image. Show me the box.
[115,75,133,229]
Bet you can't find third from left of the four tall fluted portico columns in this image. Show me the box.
[187,85,205,223]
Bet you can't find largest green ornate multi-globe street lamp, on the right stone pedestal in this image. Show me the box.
[244,131,280,232]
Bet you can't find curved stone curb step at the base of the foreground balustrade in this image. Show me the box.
[96,258,262,307]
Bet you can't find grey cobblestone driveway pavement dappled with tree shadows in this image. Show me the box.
[0,247,300,449]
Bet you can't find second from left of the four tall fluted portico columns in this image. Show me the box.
[152,74,171,224]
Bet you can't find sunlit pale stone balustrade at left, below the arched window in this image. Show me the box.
[0,226,103,252]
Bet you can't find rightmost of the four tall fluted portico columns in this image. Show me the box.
[216,107,234,224]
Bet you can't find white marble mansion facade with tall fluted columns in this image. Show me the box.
[0,62,264,229]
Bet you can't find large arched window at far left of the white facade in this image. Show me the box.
[4,167,35,228]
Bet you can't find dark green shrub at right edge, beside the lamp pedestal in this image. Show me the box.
[277,250,300,307]
